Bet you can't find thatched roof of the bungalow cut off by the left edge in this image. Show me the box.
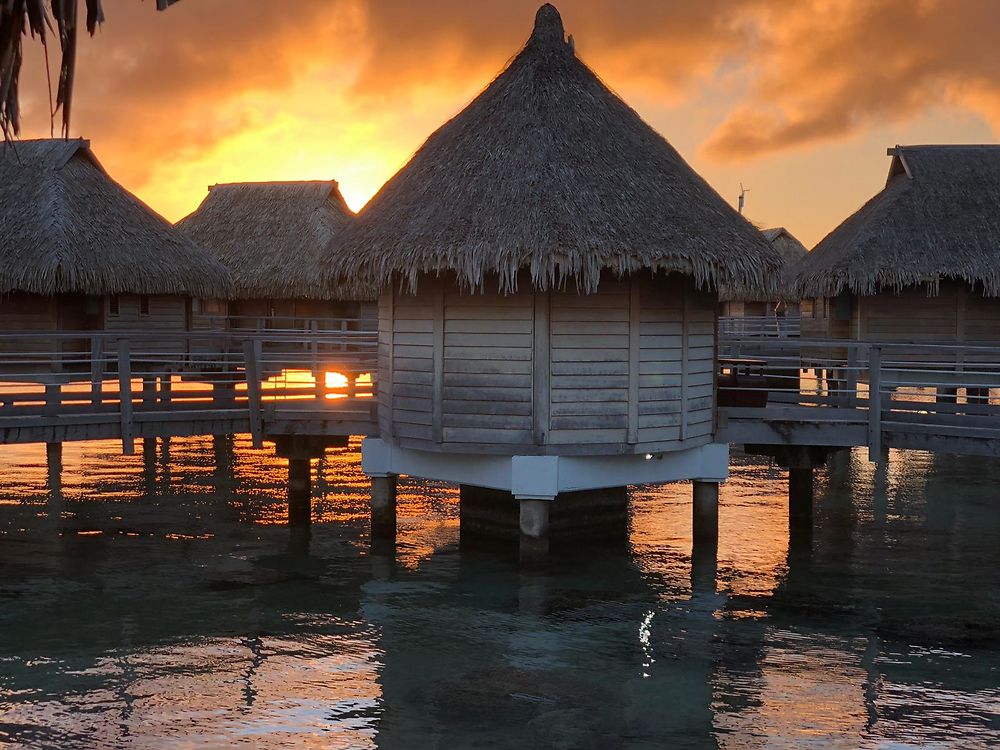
[0,139,229,296]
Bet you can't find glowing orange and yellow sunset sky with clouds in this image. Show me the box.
[15,0,1000,246]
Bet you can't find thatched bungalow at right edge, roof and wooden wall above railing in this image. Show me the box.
[795,146,1000,344]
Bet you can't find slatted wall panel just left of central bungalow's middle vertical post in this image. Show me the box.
[442,287,532,444]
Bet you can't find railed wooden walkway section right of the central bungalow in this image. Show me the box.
[718,336,1000,461]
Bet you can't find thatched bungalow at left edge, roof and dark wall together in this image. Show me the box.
[0,139,229,362]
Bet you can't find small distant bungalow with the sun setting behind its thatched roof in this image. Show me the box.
[177,180,375,328]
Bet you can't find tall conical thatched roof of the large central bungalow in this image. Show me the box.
[334,5,780,291]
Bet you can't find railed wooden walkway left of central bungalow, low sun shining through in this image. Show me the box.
[0,327,377,453]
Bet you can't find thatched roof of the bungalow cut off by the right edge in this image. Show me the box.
[794,146,1000,297]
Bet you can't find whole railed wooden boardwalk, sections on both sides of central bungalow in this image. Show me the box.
[0,321,1000,460]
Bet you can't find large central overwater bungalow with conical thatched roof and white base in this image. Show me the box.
[333,5,781,539]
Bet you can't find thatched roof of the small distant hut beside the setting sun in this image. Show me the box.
[177,180,374,299]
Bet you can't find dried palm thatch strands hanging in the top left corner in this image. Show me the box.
[0,0,179,140]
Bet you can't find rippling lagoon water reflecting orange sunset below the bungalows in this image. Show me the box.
[0,444,1000,748]
